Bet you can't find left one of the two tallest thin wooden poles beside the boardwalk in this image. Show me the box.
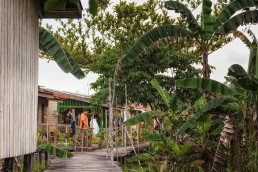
[108,79,114,165]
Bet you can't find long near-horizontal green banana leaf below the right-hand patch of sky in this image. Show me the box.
[175,78,237,96]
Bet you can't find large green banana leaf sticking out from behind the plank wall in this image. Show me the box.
[39,27,85,79]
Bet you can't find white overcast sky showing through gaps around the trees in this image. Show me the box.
[39,0,258,94]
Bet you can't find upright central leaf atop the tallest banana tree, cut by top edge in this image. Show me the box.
[201,0,214,40]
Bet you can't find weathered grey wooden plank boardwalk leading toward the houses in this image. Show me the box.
[46,144,148,172]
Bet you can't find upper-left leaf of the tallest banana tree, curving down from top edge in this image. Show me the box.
[165,1,201,32]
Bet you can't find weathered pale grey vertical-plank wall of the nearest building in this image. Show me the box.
[0,0,38,159]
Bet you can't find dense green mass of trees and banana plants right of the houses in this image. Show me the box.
[41,0,258,171]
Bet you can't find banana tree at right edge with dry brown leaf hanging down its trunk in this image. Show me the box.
[176,64,258,171]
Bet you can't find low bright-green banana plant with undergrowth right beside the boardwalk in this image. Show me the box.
[124,79,214,171]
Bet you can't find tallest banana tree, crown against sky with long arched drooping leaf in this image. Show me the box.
[117,0,258,78]
